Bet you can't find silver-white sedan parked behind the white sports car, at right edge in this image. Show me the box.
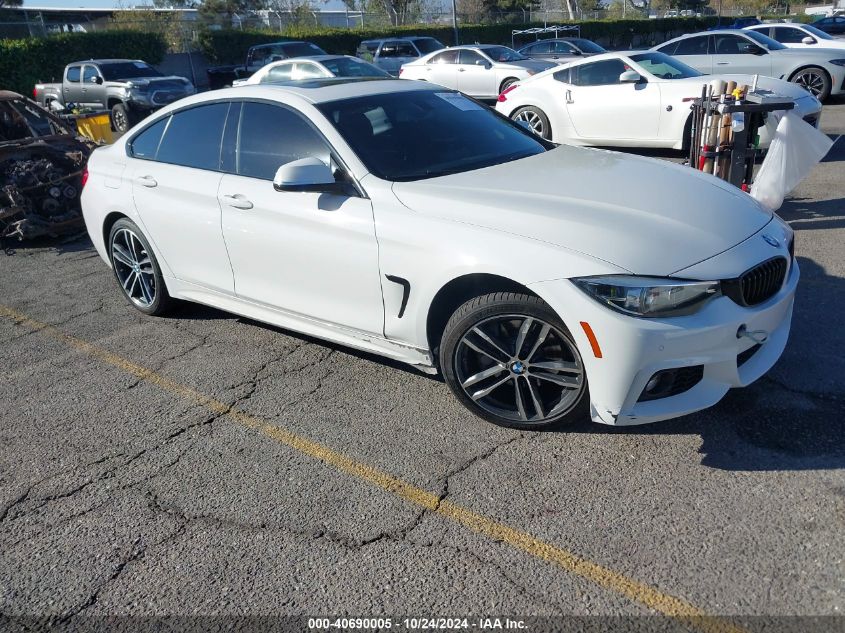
[652,29,845,101]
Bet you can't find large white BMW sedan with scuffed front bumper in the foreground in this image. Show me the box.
[82,79,799,428]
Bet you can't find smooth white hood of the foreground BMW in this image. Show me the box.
[393,145,772,275]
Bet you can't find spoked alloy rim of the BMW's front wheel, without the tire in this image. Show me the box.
[454,314,585,424]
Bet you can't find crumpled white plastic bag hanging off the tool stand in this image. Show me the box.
[751,110,833,211]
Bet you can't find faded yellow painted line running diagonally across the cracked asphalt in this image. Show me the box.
[0,306,745,633]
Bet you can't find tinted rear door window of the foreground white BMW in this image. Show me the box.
[156,103,229,170]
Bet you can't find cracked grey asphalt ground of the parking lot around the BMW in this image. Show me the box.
[0,99,845,631]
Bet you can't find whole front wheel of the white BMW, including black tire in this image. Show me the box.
[439,292,588,430]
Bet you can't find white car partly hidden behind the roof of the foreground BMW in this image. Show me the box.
[232,55,390,86]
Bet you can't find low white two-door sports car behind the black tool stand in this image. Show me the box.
[496,51,822,149]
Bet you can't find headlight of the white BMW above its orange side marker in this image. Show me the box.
[572,275,722,317]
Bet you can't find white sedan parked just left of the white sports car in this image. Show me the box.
[399,45,556,99]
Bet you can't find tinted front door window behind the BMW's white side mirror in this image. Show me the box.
[238,103,331,180]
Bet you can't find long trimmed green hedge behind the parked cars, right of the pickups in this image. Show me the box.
[199,17,716,64]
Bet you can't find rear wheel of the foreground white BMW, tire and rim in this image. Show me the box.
[109,218,172,316]
